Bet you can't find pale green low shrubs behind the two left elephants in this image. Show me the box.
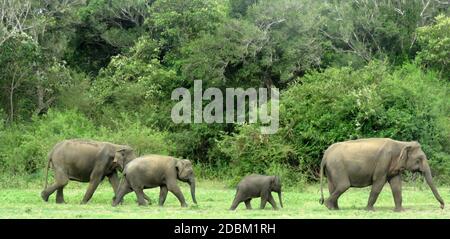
[0,110,171,176]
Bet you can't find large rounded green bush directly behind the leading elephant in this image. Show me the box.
[214,62,450,180]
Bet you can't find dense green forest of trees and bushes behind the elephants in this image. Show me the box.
[0,0,450,185]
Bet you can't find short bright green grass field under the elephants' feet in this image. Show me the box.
[0,181,450,218]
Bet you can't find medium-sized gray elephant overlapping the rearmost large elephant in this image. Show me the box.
[113,155,197,207]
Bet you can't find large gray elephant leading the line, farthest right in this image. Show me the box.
[320,138,444,211]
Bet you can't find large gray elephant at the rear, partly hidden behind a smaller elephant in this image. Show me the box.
[41,139,136,204]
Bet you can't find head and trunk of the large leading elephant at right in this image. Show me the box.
[392,142,445,209]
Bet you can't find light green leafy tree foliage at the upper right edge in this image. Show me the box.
[417,15,450,76]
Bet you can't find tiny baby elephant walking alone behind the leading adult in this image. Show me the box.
[230,174,283,210]
